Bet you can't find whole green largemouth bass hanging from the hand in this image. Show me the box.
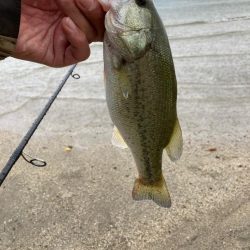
[103,0,183,208]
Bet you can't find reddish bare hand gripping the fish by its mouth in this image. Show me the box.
[14,0,105,67]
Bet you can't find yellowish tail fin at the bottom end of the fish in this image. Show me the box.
[132,177,171,208]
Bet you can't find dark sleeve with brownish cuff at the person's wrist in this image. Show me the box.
[0,0,21,60]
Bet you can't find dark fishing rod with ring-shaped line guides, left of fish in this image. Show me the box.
[0,64,80,186]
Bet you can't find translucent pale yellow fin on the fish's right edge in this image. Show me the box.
[166,118,183,161]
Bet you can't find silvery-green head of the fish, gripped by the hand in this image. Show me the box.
[105,0,153,61]
